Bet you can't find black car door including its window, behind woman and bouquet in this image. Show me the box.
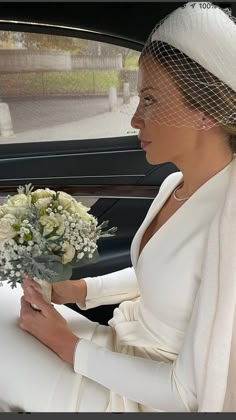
[0,18,177,323]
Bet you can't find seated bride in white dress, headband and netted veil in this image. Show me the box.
[0,3,236,412]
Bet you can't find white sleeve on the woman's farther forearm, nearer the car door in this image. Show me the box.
[77,267,139,309]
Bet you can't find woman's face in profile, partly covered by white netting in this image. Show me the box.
[131,56,203,164]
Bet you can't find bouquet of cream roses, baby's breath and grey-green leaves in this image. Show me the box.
[0,184,116,308]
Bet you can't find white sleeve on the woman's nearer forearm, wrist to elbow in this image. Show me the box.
[74,290,201,412]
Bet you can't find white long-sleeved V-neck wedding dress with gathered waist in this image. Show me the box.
[0,164,230,412]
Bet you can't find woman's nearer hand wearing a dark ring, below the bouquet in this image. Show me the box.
[20,286,79,365]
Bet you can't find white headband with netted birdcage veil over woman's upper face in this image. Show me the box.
[129,2,236,129]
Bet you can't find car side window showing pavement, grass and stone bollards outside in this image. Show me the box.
[0,31,139,144]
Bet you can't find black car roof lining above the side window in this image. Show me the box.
[1,1,233,44]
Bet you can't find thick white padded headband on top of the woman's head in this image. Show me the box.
[149,2,236,92]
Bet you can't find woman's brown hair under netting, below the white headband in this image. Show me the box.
[139,41,236,153]
